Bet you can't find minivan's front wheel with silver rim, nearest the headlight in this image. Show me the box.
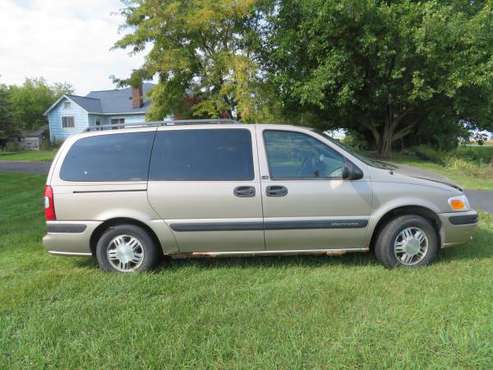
[375,215,438,268]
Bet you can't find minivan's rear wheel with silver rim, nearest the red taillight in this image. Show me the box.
[96,225,160,272]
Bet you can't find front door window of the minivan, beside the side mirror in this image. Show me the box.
[264,131,345,179]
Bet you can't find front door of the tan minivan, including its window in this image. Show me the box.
[258,129,371,251]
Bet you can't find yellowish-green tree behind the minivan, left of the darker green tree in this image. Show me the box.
[115,0,276,121]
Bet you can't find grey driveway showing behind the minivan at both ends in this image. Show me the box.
[0,161,493,213]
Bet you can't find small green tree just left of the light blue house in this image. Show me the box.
[9,78,73,130]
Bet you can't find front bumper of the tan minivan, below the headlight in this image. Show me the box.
[439,210,478,247]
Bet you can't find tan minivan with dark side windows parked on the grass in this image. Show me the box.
[43,121,478,272]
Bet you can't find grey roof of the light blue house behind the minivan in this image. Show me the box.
[44,82,154,115]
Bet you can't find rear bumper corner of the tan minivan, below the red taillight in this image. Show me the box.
[43,221,101,256]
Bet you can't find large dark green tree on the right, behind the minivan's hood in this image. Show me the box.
[263,0,493,156]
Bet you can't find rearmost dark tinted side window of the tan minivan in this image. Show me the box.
[60,132,154,182]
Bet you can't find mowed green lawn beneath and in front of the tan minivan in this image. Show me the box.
[0,174,493,369]
